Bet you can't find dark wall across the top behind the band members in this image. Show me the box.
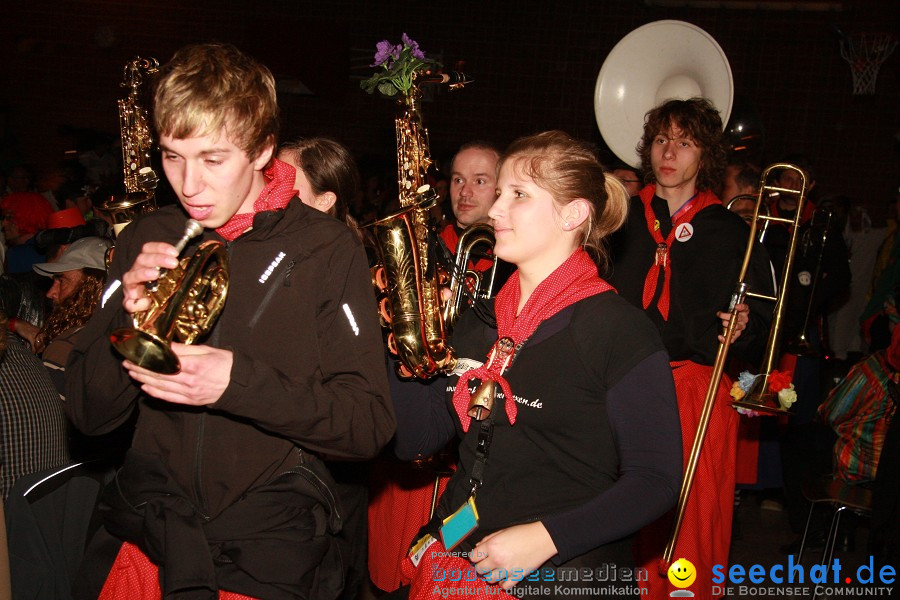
[0,0,900,218]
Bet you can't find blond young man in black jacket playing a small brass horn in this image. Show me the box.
[67,44,394,598]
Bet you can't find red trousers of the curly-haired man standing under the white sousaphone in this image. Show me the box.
[634,361,739,599]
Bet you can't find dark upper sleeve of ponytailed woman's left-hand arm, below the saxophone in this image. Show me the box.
[389,369,456,460]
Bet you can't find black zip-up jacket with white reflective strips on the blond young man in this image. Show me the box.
[66,198,394,518]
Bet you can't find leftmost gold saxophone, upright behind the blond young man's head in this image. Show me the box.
[101,57,159,235]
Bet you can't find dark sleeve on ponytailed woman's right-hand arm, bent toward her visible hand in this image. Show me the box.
[542,352,682,564]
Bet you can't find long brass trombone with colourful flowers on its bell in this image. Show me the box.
[659,163,807,576]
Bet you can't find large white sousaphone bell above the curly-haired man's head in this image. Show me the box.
[594,20,734,167]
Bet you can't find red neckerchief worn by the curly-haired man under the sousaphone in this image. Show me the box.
[640,183,722,321]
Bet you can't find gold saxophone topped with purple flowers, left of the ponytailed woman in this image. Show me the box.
[368,73,482,379]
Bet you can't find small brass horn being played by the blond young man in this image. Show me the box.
[110,219,229,374]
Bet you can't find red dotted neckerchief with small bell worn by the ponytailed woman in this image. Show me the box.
[453,248,615,431]
